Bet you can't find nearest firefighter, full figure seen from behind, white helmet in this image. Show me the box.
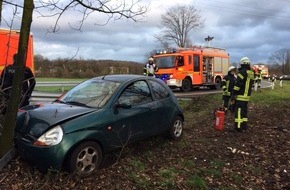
[230,57,254,132]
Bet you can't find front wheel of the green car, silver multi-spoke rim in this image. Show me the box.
[67,141,103,176]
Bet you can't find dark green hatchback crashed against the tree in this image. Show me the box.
[15,75,184,176]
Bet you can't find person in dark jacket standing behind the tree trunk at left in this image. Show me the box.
[1,54,35,108]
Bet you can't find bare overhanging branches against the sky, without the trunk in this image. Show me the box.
[36,0,149,32]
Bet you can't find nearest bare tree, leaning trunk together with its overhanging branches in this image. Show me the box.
[0,0,148,158]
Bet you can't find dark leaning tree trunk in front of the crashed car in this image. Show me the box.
[0,0,34,158]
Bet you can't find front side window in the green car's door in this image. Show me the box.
[119,81,152,106]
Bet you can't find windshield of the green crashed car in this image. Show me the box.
[57,80,121,108]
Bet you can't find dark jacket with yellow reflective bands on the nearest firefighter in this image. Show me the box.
[232,68,255,102]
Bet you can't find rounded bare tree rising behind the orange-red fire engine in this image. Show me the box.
[155,5,204,48]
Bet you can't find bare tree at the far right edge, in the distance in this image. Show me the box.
[268,48,290,74]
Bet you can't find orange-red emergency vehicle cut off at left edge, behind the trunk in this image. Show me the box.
[0,29,34,74]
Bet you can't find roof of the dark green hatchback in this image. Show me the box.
[92,74,150,82]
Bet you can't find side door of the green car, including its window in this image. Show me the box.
[107,80,158,146]
